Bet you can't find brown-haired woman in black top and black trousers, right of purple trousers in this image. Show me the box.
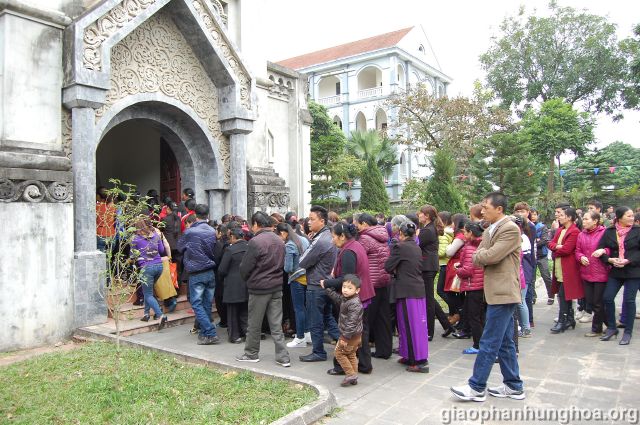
[418,205,455,341]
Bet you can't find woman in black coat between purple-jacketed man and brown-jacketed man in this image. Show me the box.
[218,227,249,344]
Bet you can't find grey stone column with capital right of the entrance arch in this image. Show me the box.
[220,118,253,219]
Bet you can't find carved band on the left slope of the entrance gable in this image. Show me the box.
[82,0,156,71]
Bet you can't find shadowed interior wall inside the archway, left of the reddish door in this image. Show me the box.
[96,121,160,195]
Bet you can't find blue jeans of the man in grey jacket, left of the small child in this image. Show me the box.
[307,289,340,359]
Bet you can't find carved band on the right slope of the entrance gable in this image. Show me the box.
[193,0,251,110]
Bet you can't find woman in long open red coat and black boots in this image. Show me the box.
[548,208,584,334]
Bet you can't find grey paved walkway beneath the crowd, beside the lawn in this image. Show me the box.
[127,289,640,425]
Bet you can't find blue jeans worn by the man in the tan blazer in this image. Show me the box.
[469,304,523,392]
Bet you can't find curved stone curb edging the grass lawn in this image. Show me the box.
[73,327,338,425]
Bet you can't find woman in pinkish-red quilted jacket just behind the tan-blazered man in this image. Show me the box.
[454,221,487,354]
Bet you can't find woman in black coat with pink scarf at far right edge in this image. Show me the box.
[592,207,640,345]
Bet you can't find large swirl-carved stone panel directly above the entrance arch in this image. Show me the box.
[96,11,231,184]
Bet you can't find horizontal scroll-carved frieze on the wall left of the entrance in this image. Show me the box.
[0,178,73,203]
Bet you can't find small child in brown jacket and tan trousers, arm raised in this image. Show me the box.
[323,274,363,387]
